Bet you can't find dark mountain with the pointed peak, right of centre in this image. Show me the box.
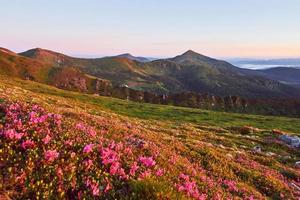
[144,51,299,98]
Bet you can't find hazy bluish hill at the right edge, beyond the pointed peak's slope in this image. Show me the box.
[258,67,300,87]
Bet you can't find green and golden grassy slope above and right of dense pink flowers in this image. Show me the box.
[0,76,300,199]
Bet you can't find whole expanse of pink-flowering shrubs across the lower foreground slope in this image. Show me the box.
[0,103,300,200]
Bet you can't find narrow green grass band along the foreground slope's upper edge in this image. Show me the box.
[0,77,300,133]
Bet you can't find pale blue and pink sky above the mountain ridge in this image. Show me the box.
[0,0,300,58]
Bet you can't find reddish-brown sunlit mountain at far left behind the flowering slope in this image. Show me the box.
[0,49,109,93]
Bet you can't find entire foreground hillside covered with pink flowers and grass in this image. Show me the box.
[0,75,300,200]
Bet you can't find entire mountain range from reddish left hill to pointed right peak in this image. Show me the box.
[2,48,300,99]
